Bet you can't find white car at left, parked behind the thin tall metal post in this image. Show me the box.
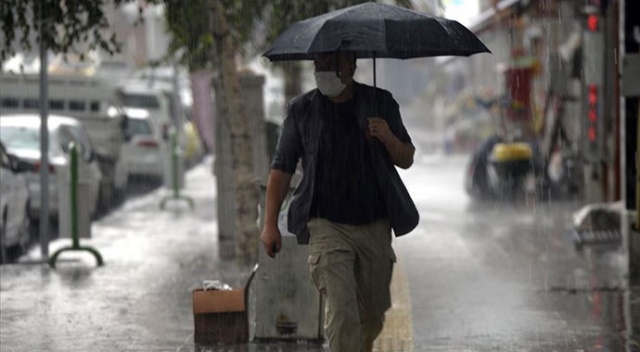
[0,114,102,219]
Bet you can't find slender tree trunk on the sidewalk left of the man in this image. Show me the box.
[213,0,259,263]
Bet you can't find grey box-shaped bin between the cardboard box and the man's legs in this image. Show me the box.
[254,186,324,343]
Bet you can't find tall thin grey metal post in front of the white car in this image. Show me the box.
[39,18,49,261]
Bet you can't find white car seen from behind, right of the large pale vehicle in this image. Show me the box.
[124,108,167,181]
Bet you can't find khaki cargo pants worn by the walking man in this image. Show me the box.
[308,219,396,352]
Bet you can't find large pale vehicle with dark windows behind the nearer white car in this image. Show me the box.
[0,72,128,211]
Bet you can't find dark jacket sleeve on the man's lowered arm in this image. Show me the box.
[271,103,302,174]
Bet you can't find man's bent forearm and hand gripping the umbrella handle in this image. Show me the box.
[369,117,416,169]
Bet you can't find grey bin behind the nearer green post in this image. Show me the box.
[58,177,91,238]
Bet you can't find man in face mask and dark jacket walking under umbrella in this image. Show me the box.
[260,52,418,352]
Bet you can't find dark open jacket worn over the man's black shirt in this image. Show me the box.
[271,82,419,244]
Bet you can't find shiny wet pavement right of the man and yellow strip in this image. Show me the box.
[396,157,624,351]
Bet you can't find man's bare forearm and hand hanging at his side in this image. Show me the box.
[260,169,293,258]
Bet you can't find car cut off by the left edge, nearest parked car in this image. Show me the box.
[0,142,32,263]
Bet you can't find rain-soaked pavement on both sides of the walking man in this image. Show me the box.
[0,153,626,352]
